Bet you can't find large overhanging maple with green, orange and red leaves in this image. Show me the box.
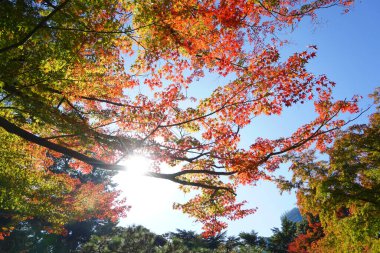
[0,0,358,236]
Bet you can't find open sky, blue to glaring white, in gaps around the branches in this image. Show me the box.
[119,0,380,236]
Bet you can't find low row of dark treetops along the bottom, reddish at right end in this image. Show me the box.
[0,209,332,253]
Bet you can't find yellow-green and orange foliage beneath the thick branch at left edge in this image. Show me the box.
[0,130,125,238]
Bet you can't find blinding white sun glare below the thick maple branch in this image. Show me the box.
[113,154,199,233]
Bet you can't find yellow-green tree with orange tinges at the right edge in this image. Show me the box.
[279,92,380,252]
